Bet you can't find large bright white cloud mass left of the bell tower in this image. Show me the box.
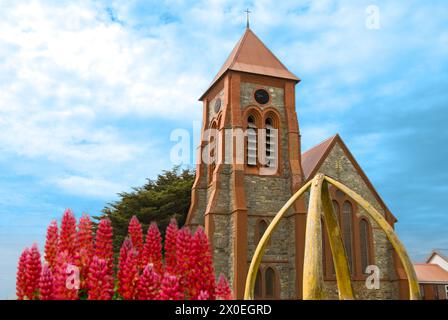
[0,1,204,197]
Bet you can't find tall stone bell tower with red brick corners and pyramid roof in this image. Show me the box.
[187,27,306,299]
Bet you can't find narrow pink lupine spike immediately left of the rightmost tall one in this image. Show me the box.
[176,227,195,297]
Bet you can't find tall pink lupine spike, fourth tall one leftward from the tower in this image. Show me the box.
[142,223,163,274]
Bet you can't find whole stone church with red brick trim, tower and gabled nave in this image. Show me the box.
[187,28,408,299]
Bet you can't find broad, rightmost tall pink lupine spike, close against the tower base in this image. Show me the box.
[187,227,215,300]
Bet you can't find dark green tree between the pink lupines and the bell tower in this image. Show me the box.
[95,166,195,253]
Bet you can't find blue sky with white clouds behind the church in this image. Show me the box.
[0,0,448,298]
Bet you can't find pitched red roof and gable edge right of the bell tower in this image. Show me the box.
[302,134,397,222]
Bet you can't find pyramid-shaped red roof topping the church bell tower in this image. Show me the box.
[200,28,300,100]
